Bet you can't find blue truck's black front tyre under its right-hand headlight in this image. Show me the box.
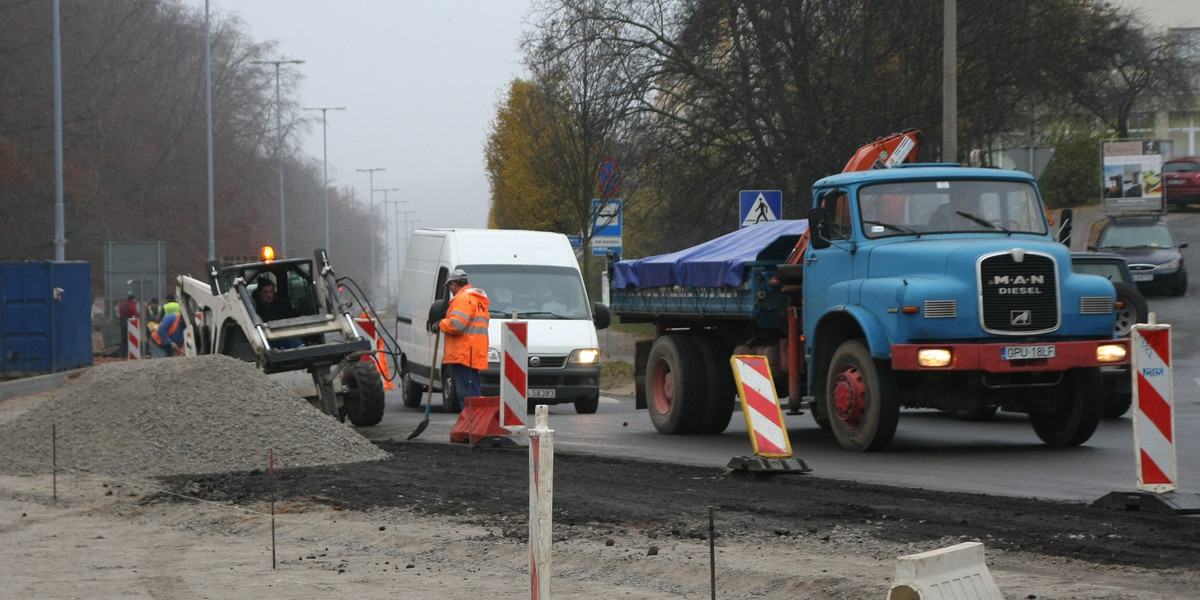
[1030,367,1104,446]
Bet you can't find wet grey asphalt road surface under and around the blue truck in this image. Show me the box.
[361,211,1200,502]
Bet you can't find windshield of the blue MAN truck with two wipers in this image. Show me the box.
[858,180,1046,238]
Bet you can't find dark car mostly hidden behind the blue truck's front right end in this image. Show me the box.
[1070,252,1150,419]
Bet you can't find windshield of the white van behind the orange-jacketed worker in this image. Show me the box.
[458,264,592,319]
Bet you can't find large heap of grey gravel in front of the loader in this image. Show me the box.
[0,355,389,476]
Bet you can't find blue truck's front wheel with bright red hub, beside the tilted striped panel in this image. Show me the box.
[826,340,900,452]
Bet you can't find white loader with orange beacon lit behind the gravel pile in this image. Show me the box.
[178,247,384,426]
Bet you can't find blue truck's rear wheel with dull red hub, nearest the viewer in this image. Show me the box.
[646,334,707,434]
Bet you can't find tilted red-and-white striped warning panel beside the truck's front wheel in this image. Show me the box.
[730,354,792,458]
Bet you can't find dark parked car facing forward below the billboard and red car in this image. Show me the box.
[1087,212,1188,296]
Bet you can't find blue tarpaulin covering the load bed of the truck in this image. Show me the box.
[613,220,809,289]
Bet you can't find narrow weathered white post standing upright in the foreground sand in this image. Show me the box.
[528,404,554,600]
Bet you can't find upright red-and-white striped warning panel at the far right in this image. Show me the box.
[1130,324,1178,492]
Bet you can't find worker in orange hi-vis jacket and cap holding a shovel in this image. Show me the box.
[431,269,488,409]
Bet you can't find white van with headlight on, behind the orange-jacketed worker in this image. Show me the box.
[396,229,612,414]
